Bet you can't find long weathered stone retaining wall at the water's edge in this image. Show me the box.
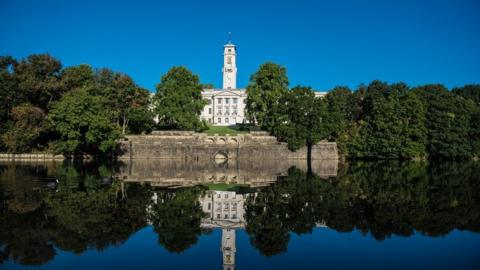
[119,131,338,160]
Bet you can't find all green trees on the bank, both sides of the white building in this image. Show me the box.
[0,54,480,159]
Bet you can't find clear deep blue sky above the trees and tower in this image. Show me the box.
[0,0,480,90]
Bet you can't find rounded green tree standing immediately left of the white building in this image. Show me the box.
[155,67,207,131]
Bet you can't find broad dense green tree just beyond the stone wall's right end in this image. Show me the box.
[347,81,426,159]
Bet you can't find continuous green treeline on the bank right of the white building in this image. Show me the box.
[247,63,480,159]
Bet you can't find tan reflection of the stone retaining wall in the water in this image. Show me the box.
[118,159,338,187]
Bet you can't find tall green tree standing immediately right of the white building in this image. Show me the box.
[246,62,288,131]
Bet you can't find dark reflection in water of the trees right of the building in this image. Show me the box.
[245,161,480,256]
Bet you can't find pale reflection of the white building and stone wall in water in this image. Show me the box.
[118,159,338,270]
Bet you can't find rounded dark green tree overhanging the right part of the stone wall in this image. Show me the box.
[272,86,329,156]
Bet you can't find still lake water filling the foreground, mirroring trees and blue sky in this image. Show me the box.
[0,160,480,269]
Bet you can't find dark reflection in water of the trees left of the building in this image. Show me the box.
[0,162,209,265]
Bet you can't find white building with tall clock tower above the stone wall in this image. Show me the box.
[200,41,326,126]
